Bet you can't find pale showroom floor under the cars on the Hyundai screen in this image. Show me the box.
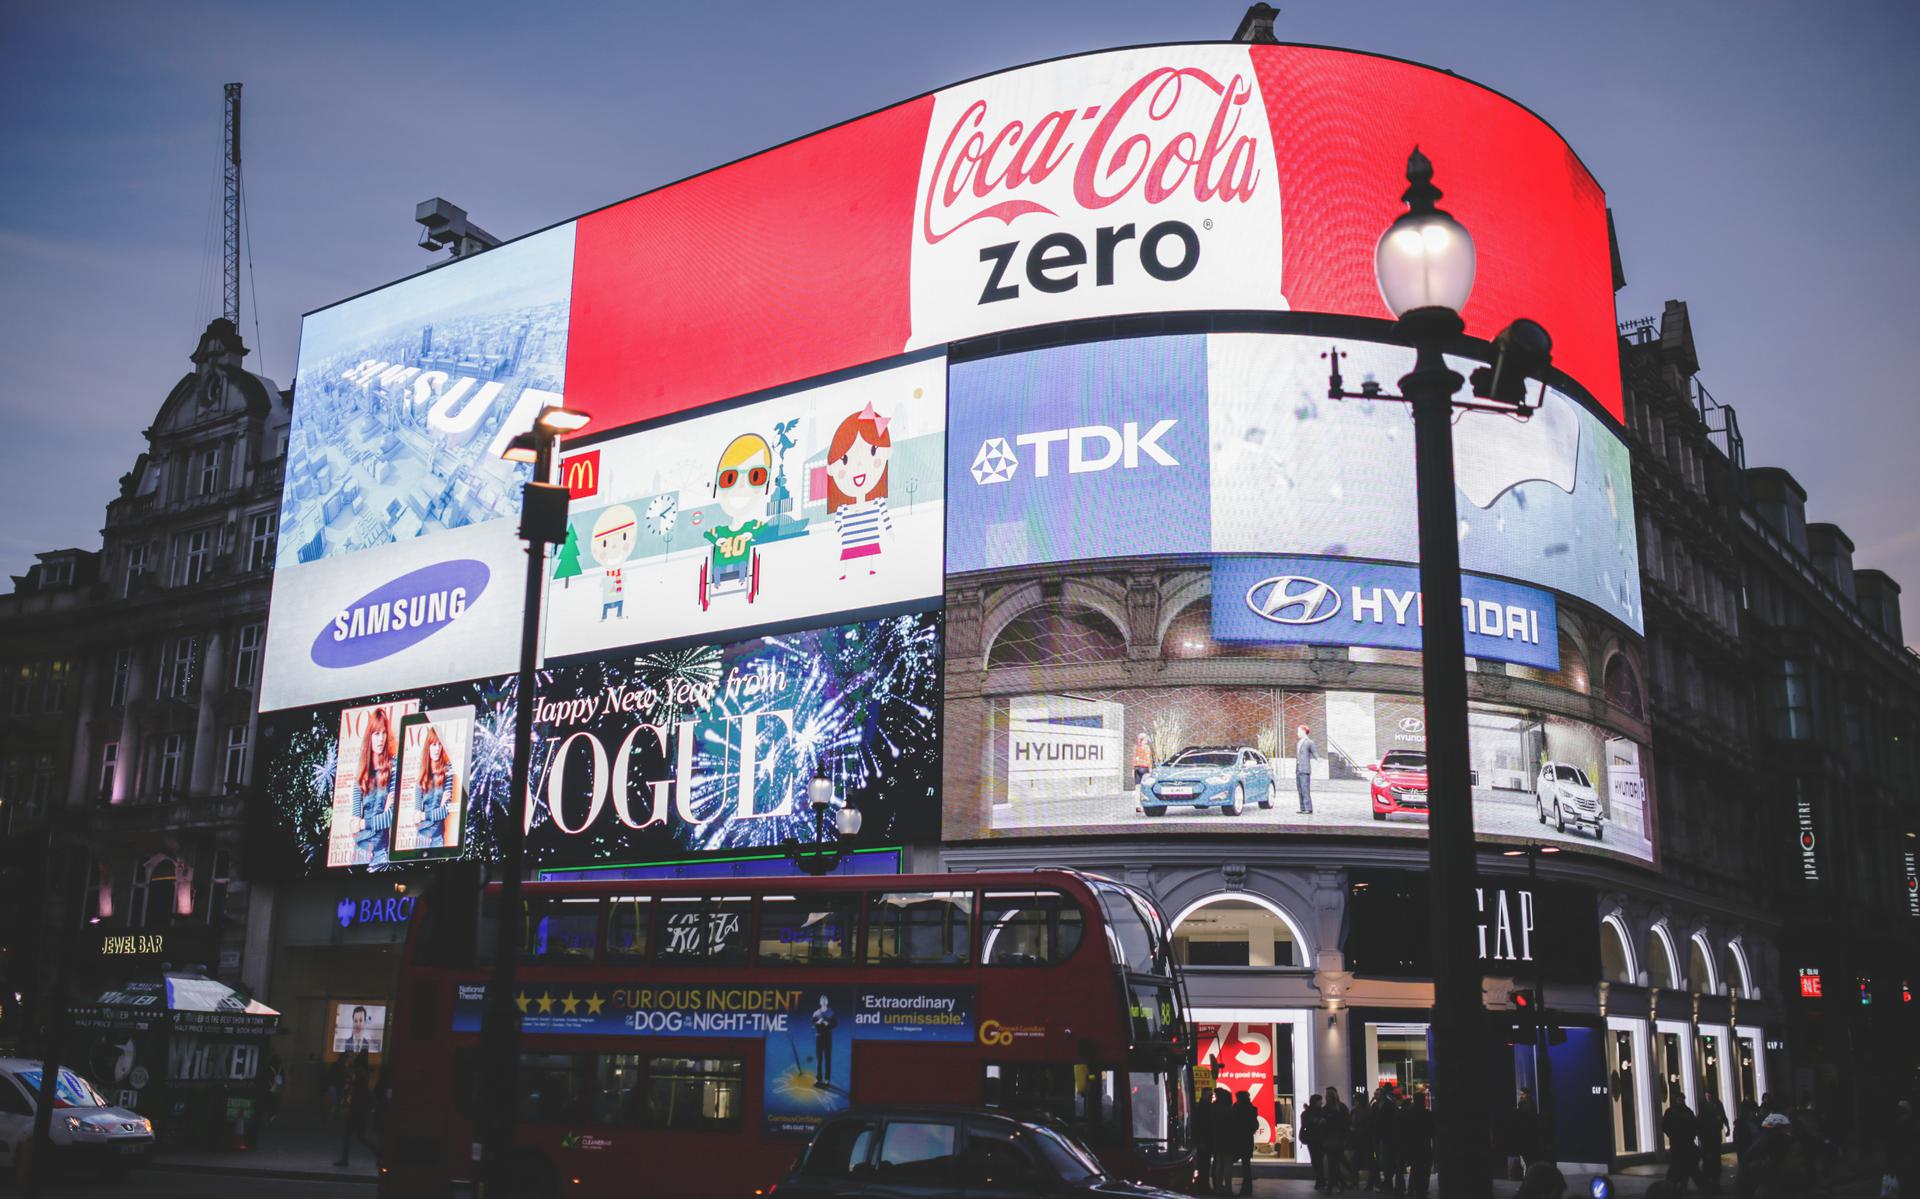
[993,774,1653,861]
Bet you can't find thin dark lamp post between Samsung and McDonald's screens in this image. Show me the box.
[480,407,591,1195]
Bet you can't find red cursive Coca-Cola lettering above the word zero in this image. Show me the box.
[920,67,1260,246]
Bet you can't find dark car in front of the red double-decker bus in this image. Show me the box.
[772,1107,1179,1199]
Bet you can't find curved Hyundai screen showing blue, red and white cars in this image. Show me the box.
[943,684,1655,863]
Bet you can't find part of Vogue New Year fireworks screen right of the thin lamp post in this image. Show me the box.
[526,613,941,867]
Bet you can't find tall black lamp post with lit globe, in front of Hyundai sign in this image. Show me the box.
[1327,148,1548,1199]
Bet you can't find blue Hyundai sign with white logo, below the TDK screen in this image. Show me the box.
[1213,557,1559,671]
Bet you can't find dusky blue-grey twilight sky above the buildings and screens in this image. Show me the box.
[0,0,1920,642]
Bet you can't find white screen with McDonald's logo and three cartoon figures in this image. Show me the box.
[547,355,947,657]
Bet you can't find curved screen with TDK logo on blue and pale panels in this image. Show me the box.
[947,334,1644,644]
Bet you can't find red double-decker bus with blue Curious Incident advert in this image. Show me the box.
[380,870,1194,1199]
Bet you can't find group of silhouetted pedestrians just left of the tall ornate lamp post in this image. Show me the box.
[1300,1086,1434,1195]
